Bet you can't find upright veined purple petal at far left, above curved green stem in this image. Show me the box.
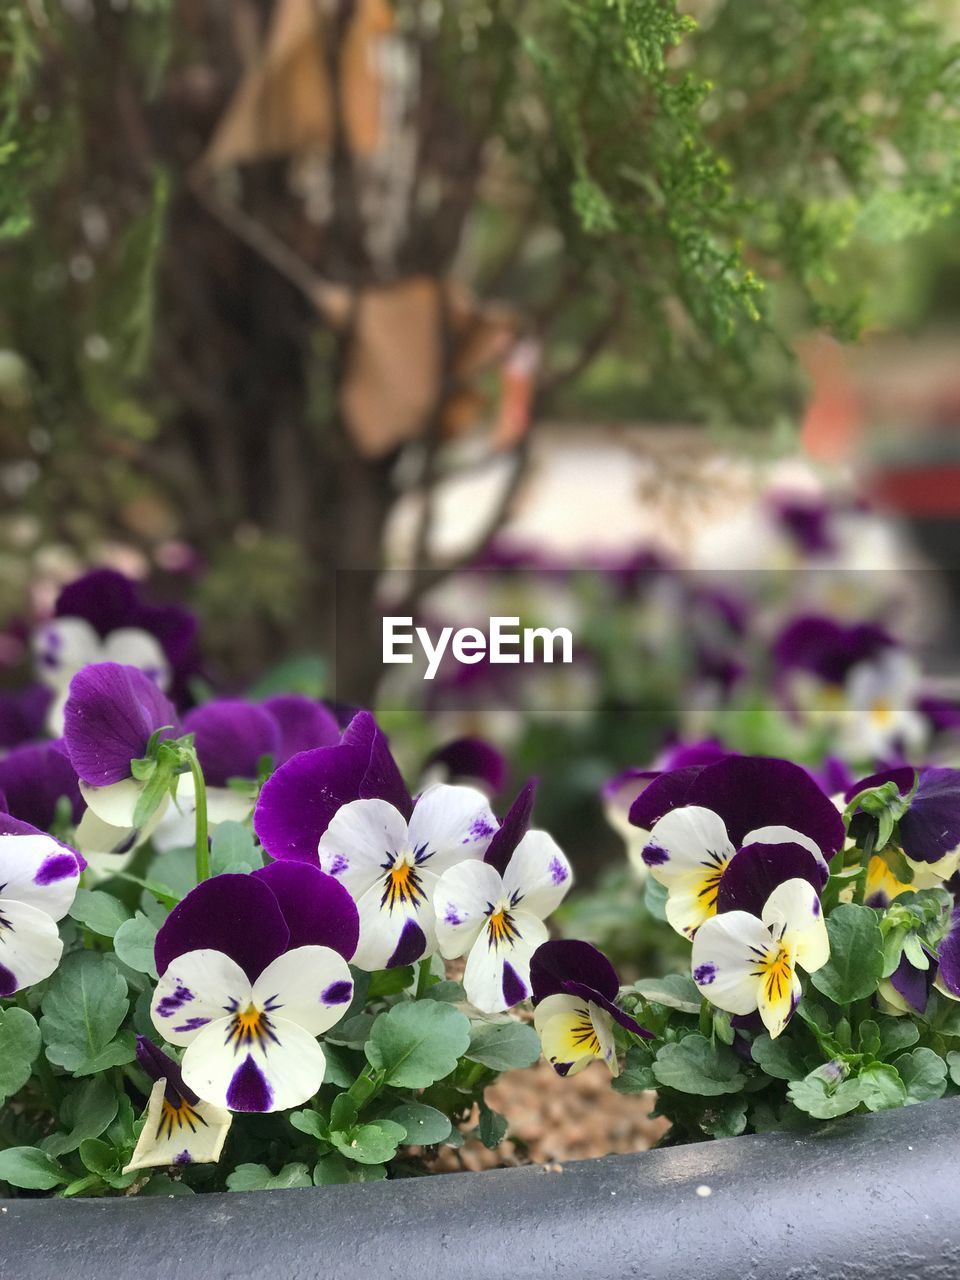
[64,662,177,787]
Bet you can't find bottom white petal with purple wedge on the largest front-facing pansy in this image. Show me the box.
[180,1018,326,1112]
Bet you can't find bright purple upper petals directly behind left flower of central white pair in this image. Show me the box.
[253,712,412,863]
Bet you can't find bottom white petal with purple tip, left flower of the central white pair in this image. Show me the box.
[352,868,436,973]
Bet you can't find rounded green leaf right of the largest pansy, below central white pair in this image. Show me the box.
[366,1000,470,1089]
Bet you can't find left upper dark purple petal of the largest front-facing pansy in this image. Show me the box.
[154,876,291,982]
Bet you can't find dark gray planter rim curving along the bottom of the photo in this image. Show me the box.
[0,1098,960,1280]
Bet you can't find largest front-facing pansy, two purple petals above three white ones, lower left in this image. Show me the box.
[151,863,358,1111]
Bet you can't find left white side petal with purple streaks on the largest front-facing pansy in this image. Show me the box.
[150,950,253,1044]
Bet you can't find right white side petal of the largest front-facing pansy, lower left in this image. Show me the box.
[253,946,353,1036]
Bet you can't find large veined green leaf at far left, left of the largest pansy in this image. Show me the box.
[40,951,133,1075]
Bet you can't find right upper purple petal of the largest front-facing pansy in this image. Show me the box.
[253,860,360,960]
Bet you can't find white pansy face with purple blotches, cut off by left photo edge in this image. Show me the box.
[0,814,82,996]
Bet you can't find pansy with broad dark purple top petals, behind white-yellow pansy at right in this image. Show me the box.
[630,755,845,937]
